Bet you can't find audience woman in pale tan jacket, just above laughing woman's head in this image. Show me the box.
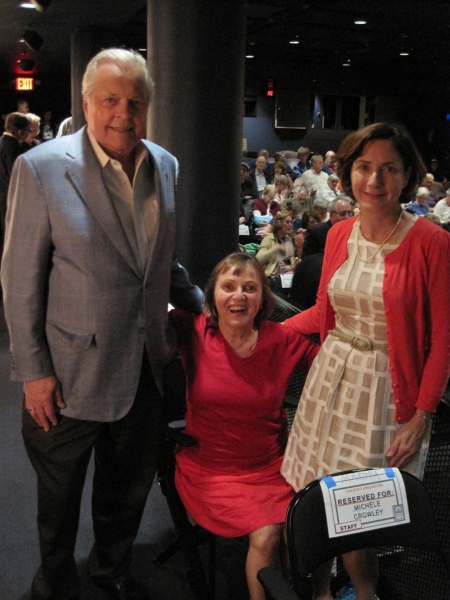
[256,211,295,277]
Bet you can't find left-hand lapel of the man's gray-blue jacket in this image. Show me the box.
[67,127,141,277]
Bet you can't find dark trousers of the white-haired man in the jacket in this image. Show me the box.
[22,357,162,600]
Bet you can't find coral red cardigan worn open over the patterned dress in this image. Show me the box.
[285,218,450,423]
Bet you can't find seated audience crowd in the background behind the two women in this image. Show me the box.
[240,146,450,310]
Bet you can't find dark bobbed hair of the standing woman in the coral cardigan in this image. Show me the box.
[336,123,427,202]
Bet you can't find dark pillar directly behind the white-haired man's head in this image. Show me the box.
[70,30,115,132]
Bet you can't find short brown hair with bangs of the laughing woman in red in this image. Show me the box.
[204,252,275,329]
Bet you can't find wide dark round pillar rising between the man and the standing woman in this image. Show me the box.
[147,0,246,286]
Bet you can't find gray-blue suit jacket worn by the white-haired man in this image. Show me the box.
[2,129,203,421]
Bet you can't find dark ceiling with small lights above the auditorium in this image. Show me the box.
[0,0,450,94]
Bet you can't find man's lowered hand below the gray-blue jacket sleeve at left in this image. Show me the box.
[23,375,66,431]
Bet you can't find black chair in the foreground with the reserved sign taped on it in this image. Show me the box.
[258,469,450,600]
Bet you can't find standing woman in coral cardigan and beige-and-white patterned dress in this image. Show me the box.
[282,123,450,600]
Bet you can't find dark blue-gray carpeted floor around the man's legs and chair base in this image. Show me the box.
[0,307,248,600]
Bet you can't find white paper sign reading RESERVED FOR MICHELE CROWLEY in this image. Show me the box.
[320,468,410,538]
